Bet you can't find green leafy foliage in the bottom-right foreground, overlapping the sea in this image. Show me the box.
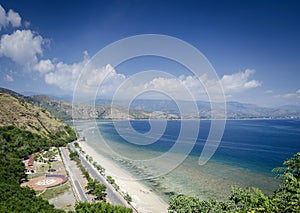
[169,152,300,213]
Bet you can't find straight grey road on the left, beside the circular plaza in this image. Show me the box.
[60,147,87,201]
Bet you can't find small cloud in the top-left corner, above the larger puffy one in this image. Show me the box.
[0,5,22,30]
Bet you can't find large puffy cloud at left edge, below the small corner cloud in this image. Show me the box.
[0,30,44,68]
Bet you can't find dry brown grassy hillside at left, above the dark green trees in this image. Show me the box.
[0,90,72,138]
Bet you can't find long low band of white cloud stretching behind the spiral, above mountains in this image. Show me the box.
[82,69,261,100]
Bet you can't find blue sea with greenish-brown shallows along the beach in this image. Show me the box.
[75,120,300,201]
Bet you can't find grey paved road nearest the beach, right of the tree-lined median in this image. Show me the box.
[70,143,130,207]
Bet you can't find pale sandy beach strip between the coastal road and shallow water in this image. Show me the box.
[80,142,168,213]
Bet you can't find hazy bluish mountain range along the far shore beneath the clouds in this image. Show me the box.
[0,88,300,120]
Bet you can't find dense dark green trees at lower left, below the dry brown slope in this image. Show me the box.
[0,126,74,212]
